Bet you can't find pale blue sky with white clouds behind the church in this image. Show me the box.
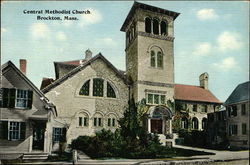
[1,1,249,102]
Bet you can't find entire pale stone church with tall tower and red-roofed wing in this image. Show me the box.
[41,2,221,143]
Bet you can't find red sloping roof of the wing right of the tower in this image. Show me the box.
[174,84,222,104]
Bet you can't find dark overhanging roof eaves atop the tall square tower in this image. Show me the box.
[121,1,180,32]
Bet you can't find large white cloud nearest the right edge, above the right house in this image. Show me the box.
[217,31,242,52]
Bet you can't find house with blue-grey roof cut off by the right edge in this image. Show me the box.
[224,81,250,148]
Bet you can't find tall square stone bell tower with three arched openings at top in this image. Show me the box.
[121,2,179,105]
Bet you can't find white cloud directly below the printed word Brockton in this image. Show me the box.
[30,23,50,39]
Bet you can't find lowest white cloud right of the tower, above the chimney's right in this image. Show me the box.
[212,57,236,71]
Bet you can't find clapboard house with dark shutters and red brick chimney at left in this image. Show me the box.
[0,60,56,159]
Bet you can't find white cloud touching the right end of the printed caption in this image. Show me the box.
[80,8,102,26]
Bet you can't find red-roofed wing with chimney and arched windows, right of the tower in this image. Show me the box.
[173,73,222,131]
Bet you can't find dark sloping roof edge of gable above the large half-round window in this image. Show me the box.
[42,53,126,93]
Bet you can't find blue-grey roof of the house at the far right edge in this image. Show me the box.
[225,81,250,105]
